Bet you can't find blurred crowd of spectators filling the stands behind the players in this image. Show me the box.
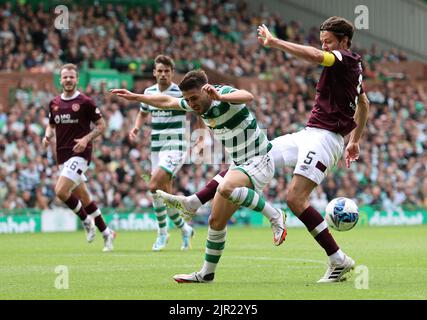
[0,1,427,211]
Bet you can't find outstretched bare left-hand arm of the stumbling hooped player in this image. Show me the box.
[110,89,182,110]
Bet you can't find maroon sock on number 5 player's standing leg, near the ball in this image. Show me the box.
[298,206,339,256]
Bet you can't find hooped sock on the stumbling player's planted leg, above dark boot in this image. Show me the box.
[200,227,227,276]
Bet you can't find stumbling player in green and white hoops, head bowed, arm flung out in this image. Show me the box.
[111,70,286,282]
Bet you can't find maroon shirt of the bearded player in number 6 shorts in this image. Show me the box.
[49,93,102,164]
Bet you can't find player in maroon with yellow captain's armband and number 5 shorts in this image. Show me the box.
[159,17,369,283]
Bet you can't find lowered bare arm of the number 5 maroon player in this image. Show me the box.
[345,93,369,168]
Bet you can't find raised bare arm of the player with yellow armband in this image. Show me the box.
[258,24,325,64]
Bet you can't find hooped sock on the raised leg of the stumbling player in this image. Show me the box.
[229,187,280,221]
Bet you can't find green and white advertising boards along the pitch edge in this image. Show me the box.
[0,206,427,234]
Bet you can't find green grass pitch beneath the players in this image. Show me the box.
[0,226,427,300]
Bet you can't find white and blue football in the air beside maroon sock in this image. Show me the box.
[325,197,359,231]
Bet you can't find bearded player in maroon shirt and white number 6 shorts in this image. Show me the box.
[43,64,115,251]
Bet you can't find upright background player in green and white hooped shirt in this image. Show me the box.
[129,55,194,251]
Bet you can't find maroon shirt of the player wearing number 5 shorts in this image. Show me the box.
[307,50,363,136]
